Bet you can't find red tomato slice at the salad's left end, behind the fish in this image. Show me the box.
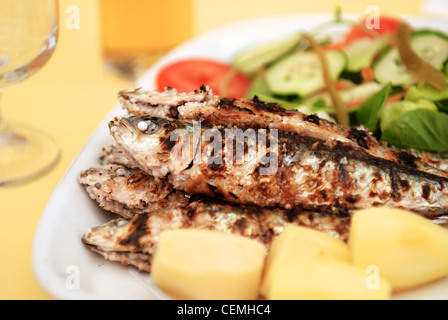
[156,59,251,99]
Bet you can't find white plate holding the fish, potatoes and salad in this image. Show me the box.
[32,15,448,300]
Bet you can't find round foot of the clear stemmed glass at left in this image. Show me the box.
[0,126,59,187]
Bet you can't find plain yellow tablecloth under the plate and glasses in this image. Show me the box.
[0,0,428,300]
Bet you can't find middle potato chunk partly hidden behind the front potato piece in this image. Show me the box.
[260,226,351,297]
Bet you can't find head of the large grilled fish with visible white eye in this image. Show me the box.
[109,115,194,177]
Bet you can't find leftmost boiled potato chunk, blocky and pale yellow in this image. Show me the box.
[151,229,266,300]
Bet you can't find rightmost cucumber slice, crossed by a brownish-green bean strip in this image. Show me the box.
[373,30,448,86]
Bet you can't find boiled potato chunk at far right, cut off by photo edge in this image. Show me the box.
[349,208,448,291]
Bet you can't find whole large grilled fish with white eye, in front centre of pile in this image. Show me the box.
[110,116,448,218]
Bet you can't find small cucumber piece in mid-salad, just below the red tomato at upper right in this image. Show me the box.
[344,37,388,72]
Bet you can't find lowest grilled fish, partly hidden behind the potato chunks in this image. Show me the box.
[82,201,350,272]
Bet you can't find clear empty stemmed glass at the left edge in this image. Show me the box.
[0,0,59,186]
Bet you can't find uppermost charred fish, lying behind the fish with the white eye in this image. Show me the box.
[119,87,448,178]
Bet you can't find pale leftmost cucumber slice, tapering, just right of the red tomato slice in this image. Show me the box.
[233,35,303,75]
